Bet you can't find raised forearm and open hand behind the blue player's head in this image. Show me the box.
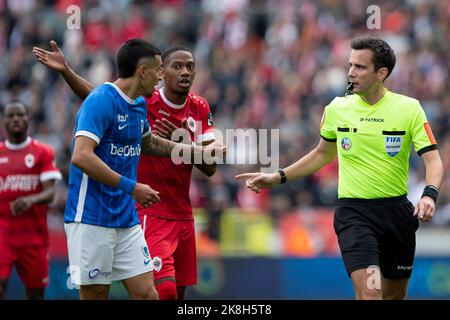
[33,40,94,100]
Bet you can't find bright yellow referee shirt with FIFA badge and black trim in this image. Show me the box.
[320,90,437,199]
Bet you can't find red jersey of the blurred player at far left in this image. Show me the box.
[0,137,61,246]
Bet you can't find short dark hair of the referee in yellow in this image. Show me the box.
[350,37,396,79]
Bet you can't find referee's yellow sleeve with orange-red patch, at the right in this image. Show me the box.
[411,103,437,156]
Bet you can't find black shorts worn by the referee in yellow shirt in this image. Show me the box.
[334,196,419,279]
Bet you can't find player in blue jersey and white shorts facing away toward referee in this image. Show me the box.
[65,39,221,299]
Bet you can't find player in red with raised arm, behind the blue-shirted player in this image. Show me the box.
[33,41,216,300]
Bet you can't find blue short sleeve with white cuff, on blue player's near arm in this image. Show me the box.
[75,89,114,144]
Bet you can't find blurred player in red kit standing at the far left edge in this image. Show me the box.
[0,100,61,299]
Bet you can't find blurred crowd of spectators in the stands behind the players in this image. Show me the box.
[0,0,450,253]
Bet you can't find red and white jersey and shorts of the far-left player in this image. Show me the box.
[0,137,61,288]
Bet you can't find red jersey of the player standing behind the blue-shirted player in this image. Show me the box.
[137,89,214,220]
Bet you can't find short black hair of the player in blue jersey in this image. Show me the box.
[116,39,161,78]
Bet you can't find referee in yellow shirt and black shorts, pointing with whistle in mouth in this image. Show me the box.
[236,38,443,299]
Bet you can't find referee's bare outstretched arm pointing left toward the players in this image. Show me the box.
[236,139,336,193]
